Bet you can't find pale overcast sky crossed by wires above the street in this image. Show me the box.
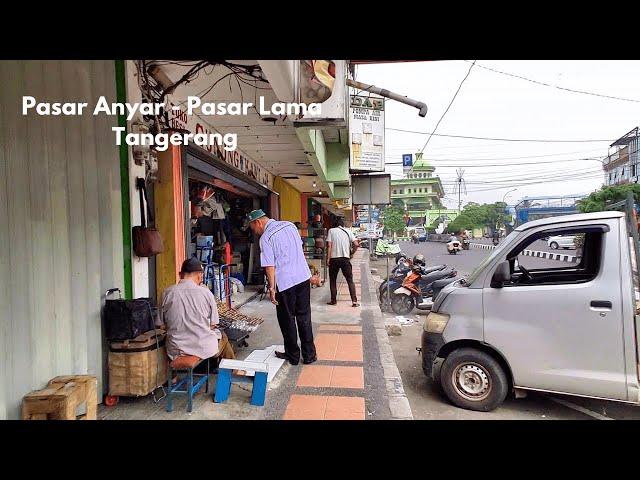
[356,60,640,208]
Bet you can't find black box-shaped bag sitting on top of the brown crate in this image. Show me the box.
[104,289,157,341]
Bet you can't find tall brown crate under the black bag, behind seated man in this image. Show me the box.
[109,329,167,397]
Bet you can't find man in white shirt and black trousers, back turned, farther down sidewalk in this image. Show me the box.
[327,218,360,307]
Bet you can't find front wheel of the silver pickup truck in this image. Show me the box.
[440,348,509,412]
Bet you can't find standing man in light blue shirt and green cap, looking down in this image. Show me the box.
[249,210,317,365]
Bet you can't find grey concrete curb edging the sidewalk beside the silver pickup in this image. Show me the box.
[363,257,413,420]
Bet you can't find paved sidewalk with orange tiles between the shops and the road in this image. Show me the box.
[99,249,412,420]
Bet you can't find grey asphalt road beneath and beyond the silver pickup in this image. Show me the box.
[372,240,640,420]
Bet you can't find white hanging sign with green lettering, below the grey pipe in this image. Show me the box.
[349,95,384,172]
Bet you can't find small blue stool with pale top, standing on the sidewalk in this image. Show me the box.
[213,359,269,407]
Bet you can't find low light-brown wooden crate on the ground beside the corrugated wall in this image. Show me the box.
[22,375,98,420]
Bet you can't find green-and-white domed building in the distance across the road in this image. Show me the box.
[391,153,458,226]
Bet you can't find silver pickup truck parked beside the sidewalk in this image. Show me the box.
[421,211,640,411]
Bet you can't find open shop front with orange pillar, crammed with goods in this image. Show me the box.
[155,146,279,304]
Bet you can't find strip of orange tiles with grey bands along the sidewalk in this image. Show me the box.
[283,250,366,420]
